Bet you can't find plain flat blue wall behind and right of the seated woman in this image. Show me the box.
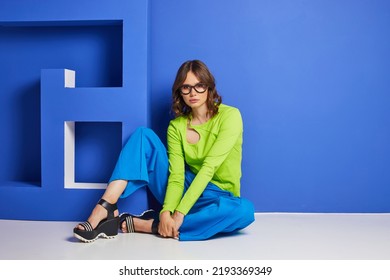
[150,0,390,212]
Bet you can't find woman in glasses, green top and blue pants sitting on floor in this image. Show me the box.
[74,60,254,242]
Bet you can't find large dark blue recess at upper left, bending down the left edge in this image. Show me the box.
[0,20,123,187]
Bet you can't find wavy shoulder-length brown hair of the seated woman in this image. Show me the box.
[172,60,222,118]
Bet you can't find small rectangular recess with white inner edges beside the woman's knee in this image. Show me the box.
[64,121,122,189]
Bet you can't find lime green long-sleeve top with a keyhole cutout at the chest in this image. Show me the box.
[162,104,243,215]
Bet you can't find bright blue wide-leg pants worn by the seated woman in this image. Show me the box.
[109,127,254,241]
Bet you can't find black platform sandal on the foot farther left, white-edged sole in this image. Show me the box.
[73,199,119,243]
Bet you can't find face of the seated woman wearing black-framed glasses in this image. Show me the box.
[181,71,208,111]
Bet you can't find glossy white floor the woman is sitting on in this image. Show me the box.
[0,213,390,260]
